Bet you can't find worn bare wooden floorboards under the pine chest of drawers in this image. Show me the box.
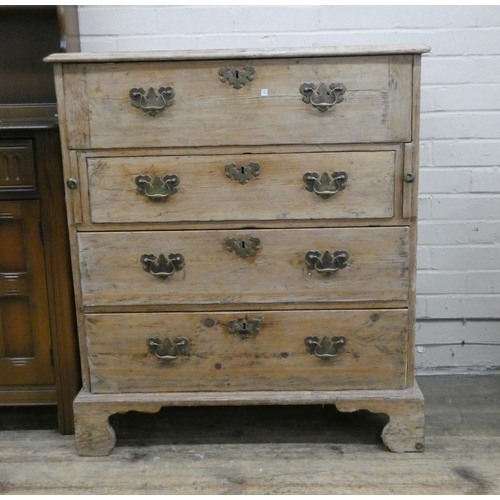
[0,374,500,495]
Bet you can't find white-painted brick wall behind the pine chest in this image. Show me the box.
[79,5,500,370]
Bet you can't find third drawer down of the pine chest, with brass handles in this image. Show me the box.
[78,227,409,306]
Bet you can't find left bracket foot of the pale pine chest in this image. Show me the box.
[73,393,116,457]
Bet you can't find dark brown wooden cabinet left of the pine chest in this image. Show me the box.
[0,6,81,434]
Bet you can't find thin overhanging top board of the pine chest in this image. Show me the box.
[44,45,430,63]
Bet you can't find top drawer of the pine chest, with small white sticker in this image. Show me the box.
[63,55,412,149]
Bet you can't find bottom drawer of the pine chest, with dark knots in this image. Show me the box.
[85,310,408,393]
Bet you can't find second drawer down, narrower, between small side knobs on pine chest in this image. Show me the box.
[87,151,396,223]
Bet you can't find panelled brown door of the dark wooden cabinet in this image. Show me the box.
[0,200,54,386]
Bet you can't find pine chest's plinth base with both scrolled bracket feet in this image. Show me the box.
[70,384,425,456]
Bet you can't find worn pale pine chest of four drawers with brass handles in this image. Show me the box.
[47,46,428,455]
